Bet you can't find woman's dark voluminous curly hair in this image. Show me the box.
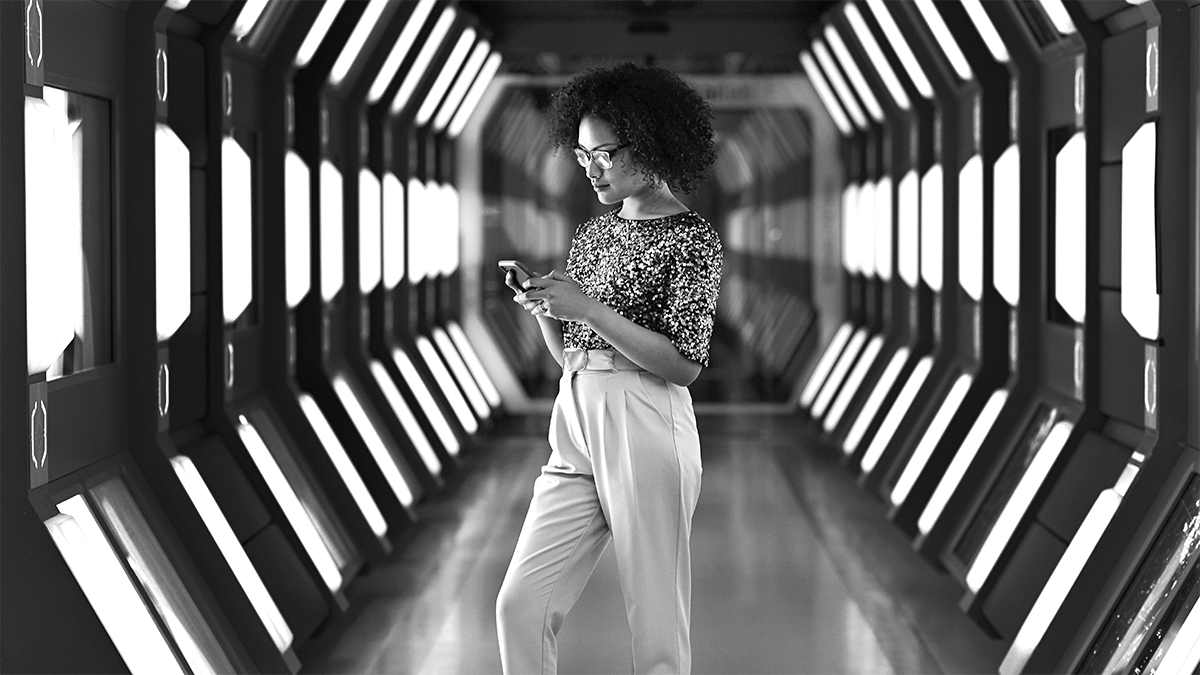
[547,62,716,192]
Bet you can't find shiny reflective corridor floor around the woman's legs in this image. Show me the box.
[300,416,1002,675]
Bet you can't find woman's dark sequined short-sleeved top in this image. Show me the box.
[563,211,721,365]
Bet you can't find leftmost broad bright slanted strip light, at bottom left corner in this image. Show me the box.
[44,495,184,675]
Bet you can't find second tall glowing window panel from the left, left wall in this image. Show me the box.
[154,124,192,341]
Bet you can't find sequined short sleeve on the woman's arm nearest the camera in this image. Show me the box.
[664,220,722,366]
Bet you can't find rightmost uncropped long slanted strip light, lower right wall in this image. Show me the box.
[1000,488,1123,675]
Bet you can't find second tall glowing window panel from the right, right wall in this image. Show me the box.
[1054,131,1094,323]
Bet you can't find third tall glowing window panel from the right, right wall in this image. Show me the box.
[991,144,1021,307]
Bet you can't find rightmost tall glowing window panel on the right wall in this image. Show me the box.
[1121,121,1158,340]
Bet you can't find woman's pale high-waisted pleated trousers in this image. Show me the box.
[496,350,701,675]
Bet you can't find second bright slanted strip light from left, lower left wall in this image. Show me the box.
[170,455,293,653]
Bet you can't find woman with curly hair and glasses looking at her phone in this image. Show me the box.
[497,64,721,675]
